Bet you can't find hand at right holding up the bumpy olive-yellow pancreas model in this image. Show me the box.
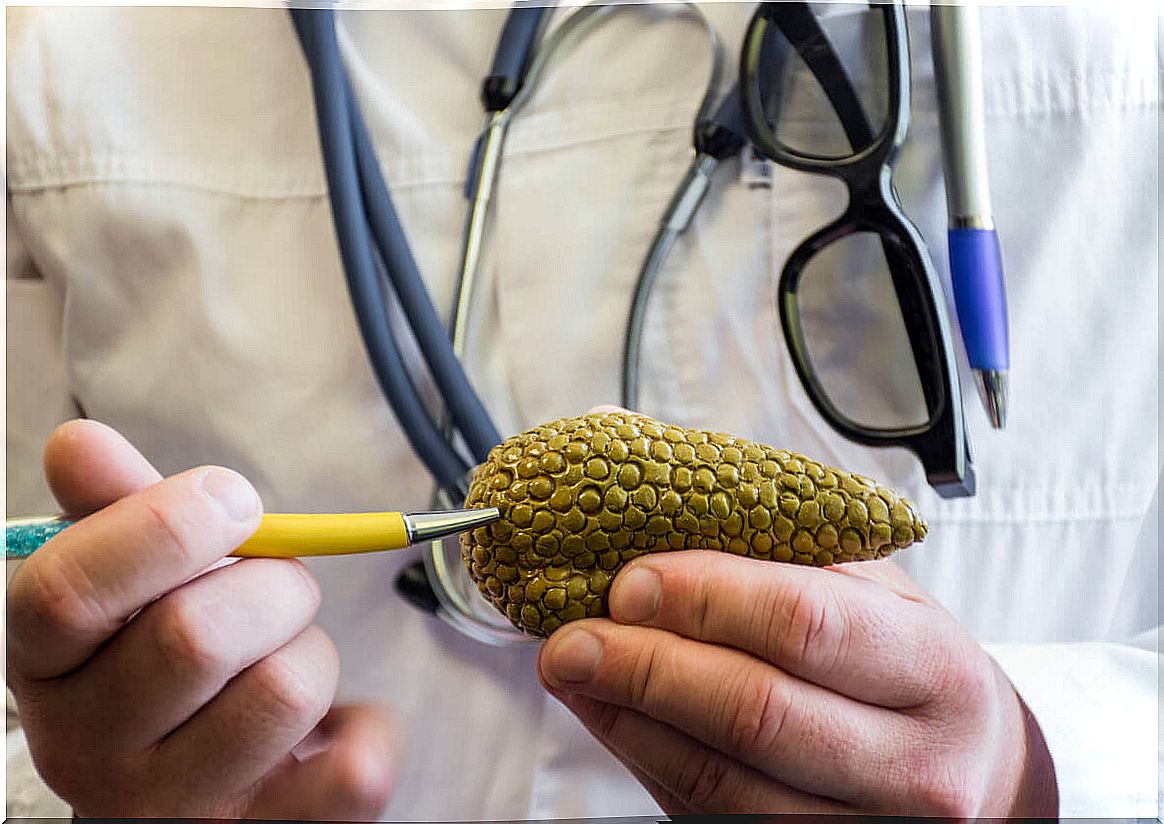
[539,550,1057,817]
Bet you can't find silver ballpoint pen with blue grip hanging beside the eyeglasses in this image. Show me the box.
[930,5,1010,429]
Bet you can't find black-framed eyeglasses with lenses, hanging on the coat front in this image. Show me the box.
[740,2,975,497]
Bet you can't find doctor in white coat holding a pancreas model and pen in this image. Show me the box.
[6,3,1161,819]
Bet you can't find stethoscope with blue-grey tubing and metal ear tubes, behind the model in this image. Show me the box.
[291,2,783,646]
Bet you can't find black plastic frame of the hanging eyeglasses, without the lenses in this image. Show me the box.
[739,1,977,498]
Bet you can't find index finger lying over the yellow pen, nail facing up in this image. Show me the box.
[8,467,261,679]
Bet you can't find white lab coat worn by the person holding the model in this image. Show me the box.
[6,3,1161,819]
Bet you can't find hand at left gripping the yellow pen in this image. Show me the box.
[8,421,392,819]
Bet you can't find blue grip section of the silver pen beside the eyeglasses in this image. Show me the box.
[949,228,1010,370]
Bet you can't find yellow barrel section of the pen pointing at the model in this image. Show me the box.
[230,512,409,557]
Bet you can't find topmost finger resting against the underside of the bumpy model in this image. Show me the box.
[609,550,957,709]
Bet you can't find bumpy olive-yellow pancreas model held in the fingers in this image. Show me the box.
[461,413,927,637]
